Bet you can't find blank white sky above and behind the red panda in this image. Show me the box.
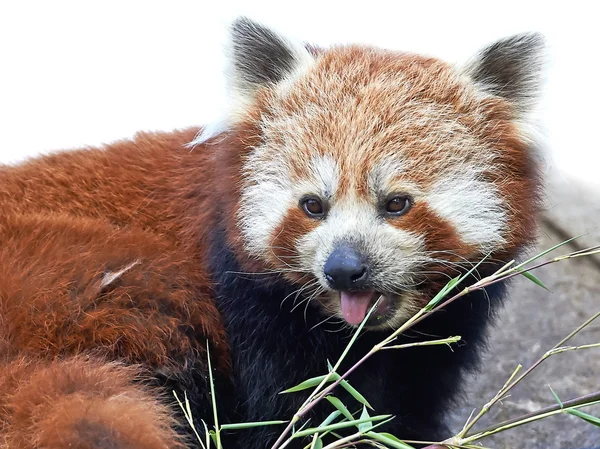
[0,0,600,185]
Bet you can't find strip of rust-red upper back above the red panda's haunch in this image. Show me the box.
[0,129,206,238]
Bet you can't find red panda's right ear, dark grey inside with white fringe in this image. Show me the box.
[465,33,544,113]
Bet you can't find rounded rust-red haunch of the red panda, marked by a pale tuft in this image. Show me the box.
[0,214,226,367]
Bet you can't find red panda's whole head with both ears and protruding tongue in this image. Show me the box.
[203,19,541,327]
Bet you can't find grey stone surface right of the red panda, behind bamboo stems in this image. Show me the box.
[452,176,600,449]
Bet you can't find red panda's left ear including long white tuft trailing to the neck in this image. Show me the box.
[190,17,314,146]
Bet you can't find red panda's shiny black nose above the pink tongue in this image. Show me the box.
[323,246,368,290]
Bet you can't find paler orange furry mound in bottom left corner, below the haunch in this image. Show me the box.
[0,357,183,449]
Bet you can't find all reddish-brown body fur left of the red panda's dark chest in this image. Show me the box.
[0,129,229,448]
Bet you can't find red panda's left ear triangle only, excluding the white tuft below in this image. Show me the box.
[229,17,313,100]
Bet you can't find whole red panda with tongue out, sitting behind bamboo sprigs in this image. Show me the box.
[0,18,543,449]
